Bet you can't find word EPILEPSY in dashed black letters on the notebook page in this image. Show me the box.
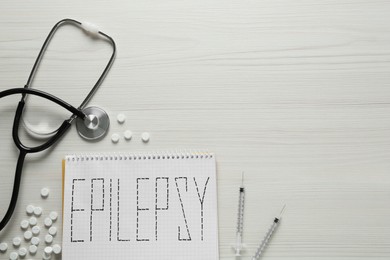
[68,176,215,243]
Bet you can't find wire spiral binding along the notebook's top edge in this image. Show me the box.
[65,151,214,162]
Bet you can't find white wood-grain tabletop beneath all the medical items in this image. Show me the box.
[0,0,390,260]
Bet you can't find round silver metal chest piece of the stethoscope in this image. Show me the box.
[76,107,110,141]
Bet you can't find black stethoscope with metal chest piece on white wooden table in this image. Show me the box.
[0,19,116,231]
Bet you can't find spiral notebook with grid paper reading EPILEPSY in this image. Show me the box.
[62,153,219,260]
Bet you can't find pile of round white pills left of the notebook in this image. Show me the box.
[0,188,61,260]
